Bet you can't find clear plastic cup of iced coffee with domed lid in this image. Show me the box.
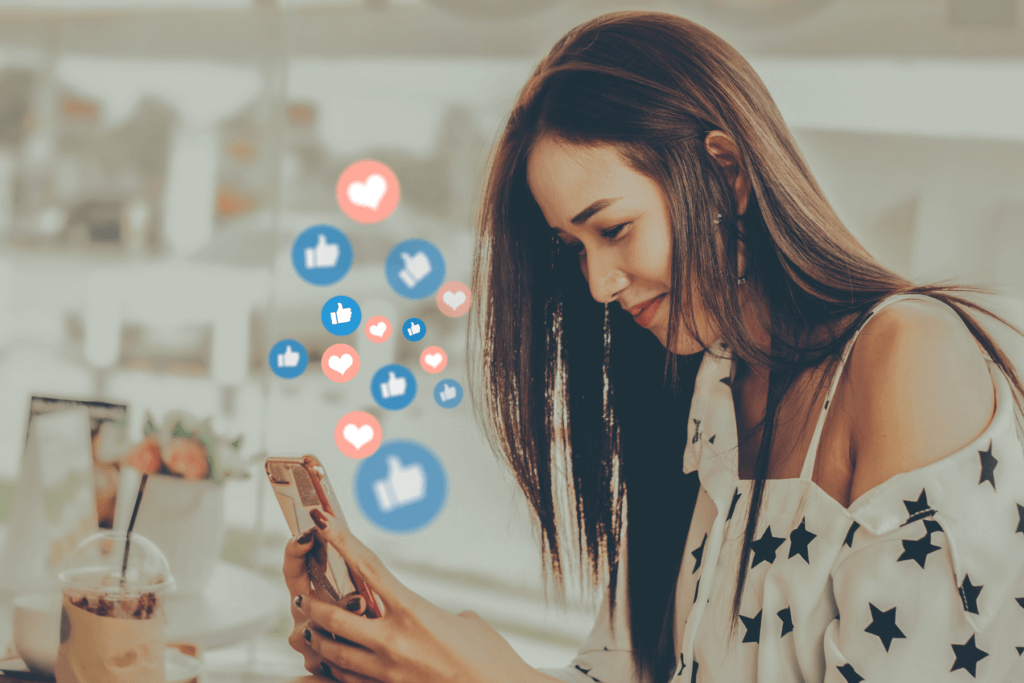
[54,531,174,683]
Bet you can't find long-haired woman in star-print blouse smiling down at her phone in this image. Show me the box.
[285,12,1024,683]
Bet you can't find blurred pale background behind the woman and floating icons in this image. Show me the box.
[0,0,1024,680]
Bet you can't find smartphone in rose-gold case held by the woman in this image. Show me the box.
[263,456,384,617]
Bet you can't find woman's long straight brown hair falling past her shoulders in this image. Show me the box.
[469,11,1024,680]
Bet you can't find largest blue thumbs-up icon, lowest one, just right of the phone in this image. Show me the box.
[355,440,447,532]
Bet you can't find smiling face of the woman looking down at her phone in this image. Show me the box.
[526,136,719,354]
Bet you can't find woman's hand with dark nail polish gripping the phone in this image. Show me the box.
[286,510,551,683]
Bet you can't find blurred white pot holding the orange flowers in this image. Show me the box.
[114,465,226,597]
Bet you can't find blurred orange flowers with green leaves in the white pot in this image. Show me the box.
[122,412,249,481]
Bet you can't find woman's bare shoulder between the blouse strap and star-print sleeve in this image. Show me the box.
[845,299,995,503]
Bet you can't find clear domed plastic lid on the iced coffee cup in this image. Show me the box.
[57,530,174,594]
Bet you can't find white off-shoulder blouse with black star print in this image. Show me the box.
[541,295,1024,683]
